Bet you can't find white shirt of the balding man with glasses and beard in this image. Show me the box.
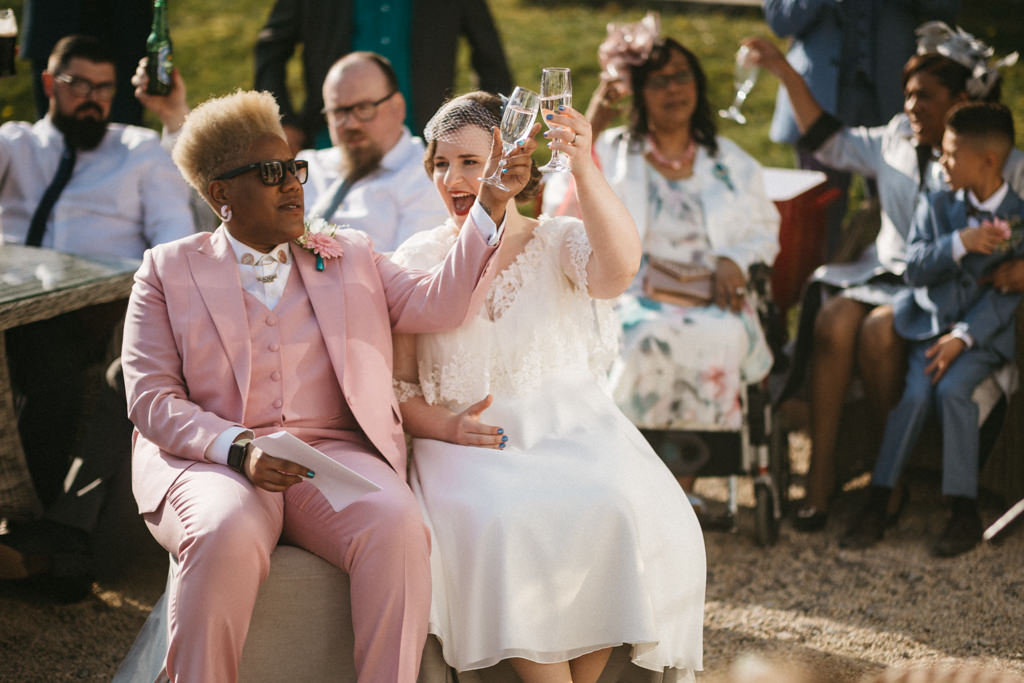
[298,128,447,252]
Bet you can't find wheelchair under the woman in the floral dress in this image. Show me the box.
[640,263,790,547]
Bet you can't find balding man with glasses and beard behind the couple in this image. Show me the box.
[299,52,447,252]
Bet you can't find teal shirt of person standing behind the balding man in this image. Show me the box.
[352,0,417,134]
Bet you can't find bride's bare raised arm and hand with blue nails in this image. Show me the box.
[545,108,641,299]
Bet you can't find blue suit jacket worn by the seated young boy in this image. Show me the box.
[893,184,1024,360]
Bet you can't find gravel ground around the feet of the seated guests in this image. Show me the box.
[0,437,1024,683]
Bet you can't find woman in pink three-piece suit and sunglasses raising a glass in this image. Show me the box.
[123,92,536,682]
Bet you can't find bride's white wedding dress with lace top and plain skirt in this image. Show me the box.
[393,218,706,679]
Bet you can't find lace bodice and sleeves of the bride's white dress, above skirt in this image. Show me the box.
[392,217,620,408]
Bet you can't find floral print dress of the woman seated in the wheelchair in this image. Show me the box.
[610,169,772,430]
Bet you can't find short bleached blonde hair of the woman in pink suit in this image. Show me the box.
[172,90,287,202]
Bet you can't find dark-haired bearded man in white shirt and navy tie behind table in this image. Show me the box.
[0,36,195,595]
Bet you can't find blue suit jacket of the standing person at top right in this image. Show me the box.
[764,0,959,144]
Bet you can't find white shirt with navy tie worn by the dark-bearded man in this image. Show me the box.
[0,116,195,258]
